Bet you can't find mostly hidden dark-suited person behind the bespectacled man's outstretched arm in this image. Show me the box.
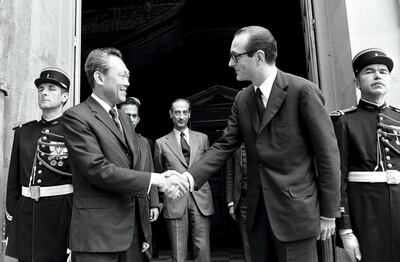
[225,145,251,262]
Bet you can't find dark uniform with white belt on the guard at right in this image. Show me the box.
[331,100,400,262]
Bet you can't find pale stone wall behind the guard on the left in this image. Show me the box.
[0,0,79,260]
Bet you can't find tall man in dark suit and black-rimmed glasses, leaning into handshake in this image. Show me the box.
[185,26,340,262]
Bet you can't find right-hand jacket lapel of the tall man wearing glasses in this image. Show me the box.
[258,70,287,132]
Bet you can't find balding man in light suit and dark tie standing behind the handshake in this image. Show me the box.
[154,98,214,262]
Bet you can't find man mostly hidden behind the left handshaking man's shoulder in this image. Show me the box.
[118,97,161,260]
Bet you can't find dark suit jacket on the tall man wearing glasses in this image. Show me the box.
[188,70,340,241]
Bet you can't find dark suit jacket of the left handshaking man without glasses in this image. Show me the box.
[63,97,150,252]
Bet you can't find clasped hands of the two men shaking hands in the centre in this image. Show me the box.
[152,170,190,199]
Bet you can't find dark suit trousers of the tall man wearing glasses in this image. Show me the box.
[248,193,318,262]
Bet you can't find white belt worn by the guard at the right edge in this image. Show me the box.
[348,170,400,184]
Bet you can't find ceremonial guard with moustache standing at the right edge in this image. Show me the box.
[331,48,400,262]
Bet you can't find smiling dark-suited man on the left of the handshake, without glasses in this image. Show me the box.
[63,48,187,261]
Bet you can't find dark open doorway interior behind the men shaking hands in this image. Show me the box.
[81,0,307,254]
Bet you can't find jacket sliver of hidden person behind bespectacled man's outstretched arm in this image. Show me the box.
[225,148,246,210]
